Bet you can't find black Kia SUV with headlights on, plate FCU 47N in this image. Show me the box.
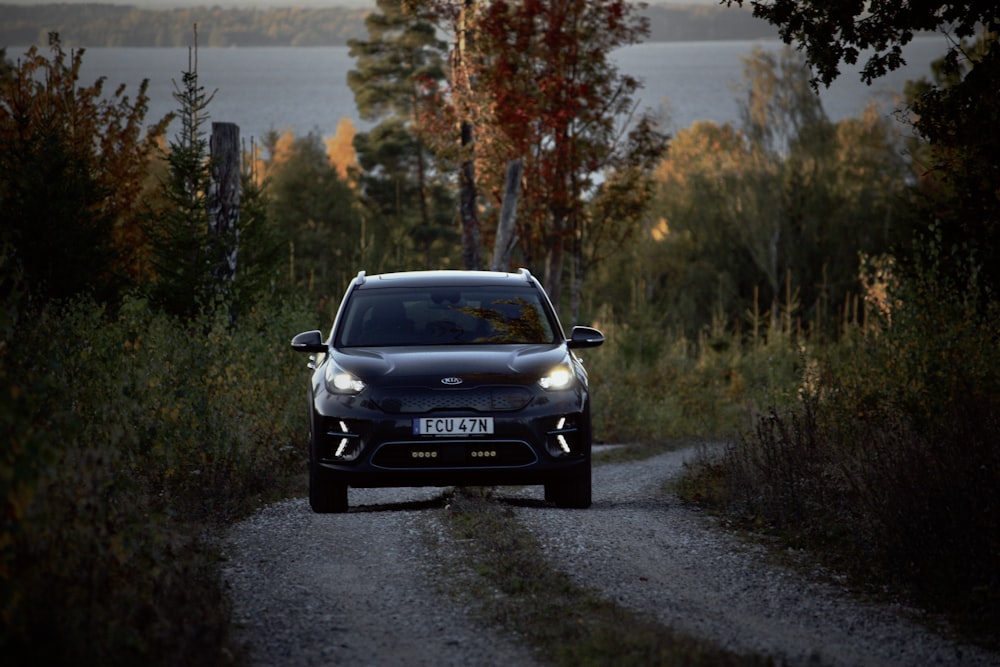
[292,269,604,512]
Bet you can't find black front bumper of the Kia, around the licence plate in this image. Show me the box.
[310,391,590,487]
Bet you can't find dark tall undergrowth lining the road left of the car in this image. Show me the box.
[0,298,314,665]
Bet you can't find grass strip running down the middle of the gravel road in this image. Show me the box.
[441,489,769,667]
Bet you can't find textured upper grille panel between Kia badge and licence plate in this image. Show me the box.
[372,387,532,414]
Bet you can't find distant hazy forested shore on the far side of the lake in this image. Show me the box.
[0,3,777,47]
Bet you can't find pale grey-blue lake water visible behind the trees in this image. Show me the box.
[48,36,947,144]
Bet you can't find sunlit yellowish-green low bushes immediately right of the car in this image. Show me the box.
[584,306,804,442]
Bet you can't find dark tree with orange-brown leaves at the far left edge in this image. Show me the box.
[0,37,165,298]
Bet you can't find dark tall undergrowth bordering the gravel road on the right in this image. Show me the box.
[684,264,1000,643]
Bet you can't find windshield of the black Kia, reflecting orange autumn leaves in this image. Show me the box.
[336,287,556,347]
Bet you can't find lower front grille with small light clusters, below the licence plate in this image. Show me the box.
[372,441,538,470]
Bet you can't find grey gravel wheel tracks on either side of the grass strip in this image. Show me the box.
[225,450,1000,667]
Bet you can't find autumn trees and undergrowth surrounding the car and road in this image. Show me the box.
[0,0,1000,665]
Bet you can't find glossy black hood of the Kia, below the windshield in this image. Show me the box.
[333,344,568,388]
